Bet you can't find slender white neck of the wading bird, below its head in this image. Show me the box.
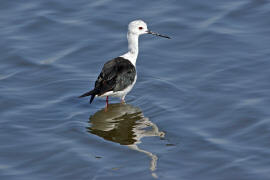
[120,32,139,66]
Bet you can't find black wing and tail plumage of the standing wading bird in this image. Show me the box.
[80,57,136,104]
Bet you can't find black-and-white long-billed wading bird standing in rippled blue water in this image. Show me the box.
[79,20,170,107]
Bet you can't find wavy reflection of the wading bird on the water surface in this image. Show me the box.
[87,104,165,177]
